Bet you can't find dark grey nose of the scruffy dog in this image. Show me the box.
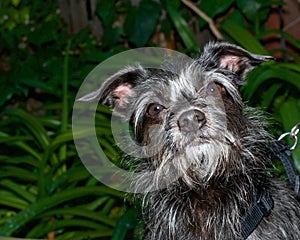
[178,110,206,133]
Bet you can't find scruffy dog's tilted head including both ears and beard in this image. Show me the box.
[79,43,271,190]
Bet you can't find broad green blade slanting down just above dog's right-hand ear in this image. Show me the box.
[221,20,268,55]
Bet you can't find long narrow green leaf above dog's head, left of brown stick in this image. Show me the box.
[167,4,199,52]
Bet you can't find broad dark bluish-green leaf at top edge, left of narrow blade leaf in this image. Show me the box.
[124,0,161,47]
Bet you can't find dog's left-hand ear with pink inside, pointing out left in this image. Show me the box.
[77,66,146,111]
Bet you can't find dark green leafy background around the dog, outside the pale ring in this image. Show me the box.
[0,0,300,240]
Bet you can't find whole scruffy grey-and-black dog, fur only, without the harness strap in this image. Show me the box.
[81,42,300,240]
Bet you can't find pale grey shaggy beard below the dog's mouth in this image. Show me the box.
[133,133,239,192]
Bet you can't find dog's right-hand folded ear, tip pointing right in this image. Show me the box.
[200,42,274,84]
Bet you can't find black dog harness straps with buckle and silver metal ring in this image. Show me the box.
[241,123,300,239]
